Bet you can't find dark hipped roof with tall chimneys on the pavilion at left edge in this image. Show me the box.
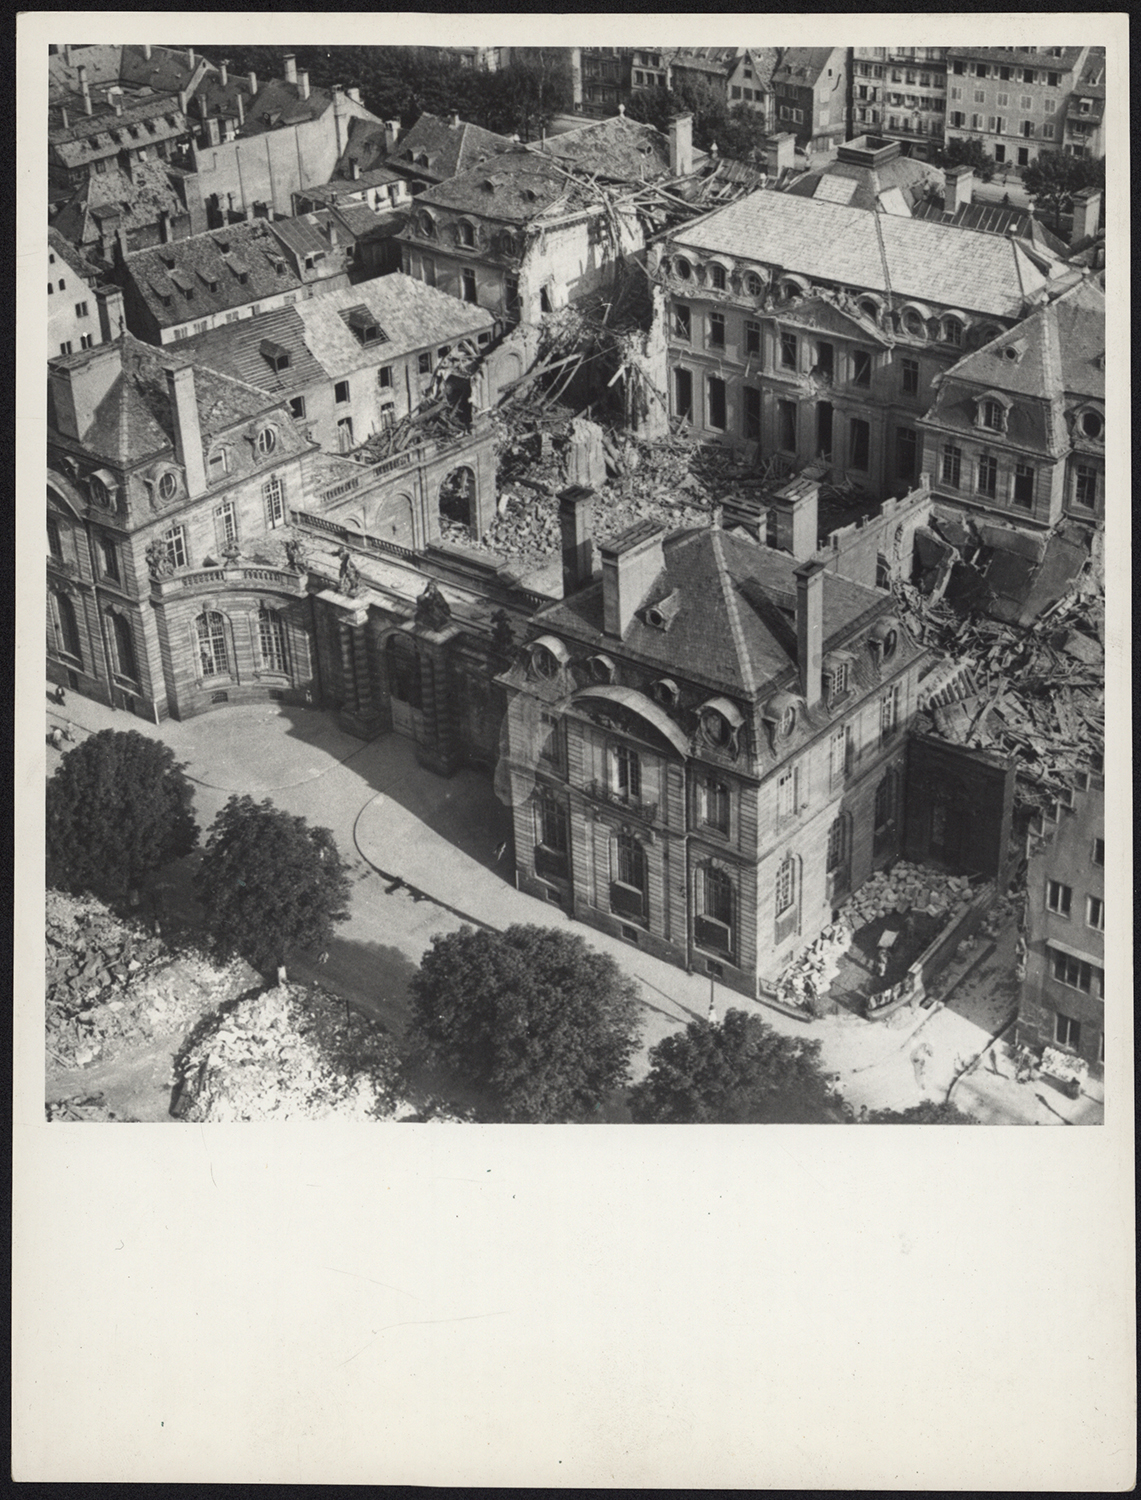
[48,333,286,467]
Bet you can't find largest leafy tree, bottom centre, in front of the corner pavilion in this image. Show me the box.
[409,926,639,1124]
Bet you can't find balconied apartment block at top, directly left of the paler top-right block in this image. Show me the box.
[850,47,948,158]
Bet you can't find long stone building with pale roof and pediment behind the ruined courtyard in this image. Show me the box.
[651,174,1072,497]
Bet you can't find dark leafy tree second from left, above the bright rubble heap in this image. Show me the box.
[195,797,349,971]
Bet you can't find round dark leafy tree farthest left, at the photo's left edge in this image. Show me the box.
[46,729,198,893]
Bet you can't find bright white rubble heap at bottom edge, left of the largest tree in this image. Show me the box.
[171,984,399,1122]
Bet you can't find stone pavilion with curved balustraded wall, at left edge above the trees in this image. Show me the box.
[46,333,312,722]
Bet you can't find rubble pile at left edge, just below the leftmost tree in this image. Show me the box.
[46,891,250,1068]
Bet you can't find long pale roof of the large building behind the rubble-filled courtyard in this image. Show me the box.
[670,191,1047,318]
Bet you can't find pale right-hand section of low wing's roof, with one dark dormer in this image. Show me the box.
[292,272,495,377]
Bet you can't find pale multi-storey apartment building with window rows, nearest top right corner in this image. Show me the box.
[946,47,1090,168]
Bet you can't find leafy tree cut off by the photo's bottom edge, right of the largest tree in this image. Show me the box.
[630,1010,841,1125]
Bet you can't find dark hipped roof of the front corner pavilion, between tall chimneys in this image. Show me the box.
[535,527,889,701]
